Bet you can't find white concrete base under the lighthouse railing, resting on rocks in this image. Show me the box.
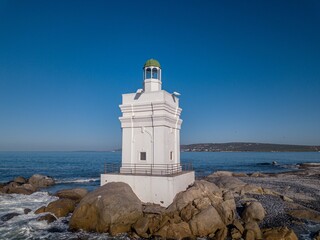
[101,171,195,207]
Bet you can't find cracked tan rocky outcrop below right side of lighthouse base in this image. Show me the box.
[133,180,236,239]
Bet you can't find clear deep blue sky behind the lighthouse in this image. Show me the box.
[0,0,320,150]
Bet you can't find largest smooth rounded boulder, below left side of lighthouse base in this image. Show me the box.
[69,182,142,235]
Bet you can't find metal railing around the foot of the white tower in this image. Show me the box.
[104,163,193,176]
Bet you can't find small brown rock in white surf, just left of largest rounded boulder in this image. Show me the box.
[45,199,76,218]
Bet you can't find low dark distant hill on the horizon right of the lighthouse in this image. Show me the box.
[181,142,320,152]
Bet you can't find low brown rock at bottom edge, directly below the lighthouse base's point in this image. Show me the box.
[154,222,193,239]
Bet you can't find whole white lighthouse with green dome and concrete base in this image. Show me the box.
[101,59,194,206]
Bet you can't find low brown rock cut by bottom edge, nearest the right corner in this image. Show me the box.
[262,227,298,240]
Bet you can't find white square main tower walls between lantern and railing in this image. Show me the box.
[120,90,182,170]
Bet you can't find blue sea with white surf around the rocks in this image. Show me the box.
[0,152,320,239]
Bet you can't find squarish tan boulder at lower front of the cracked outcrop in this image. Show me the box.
[189,206,225,237]
